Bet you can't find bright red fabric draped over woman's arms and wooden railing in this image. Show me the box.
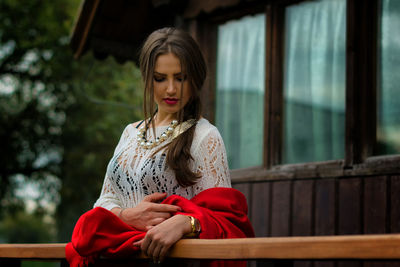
[66,188,254,267]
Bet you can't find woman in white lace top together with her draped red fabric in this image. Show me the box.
[66,28,254,266]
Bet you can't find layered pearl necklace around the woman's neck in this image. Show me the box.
[137,119,196,149]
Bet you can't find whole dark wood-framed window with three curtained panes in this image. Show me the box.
[203,0,400,178]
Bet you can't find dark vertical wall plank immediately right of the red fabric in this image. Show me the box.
[250,183,271,237]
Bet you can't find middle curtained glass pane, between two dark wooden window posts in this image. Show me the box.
[282,0,346,163]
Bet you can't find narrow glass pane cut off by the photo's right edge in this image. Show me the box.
[377,0,400,155]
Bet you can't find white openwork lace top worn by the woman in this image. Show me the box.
[94,118,231,210]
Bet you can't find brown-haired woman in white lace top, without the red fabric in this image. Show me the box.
[95,28,231,261]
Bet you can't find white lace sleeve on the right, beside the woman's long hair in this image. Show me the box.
[192,127,231,195]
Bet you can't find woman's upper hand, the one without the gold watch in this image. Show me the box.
[113,193,181,231]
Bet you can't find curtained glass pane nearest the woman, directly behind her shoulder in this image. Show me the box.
[216,14,265,169]
